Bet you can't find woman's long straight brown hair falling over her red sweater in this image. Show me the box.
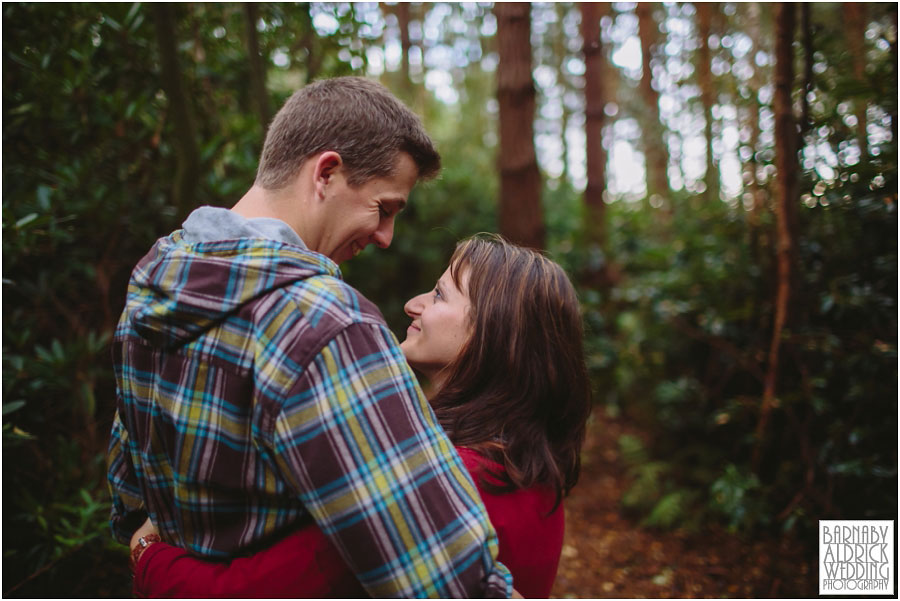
[431,235,591,509]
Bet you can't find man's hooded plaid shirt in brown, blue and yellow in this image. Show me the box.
[108,231,511,598]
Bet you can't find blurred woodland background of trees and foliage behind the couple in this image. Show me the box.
[2,2,898,596]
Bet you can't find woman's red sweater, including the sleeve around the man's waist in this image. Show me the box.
[134,447,565,598]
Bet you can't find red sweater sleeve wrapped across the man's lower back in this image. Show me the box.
[134,525,367,598]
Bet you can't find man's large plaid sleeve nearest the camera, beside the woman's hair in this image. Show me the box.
[271,323,512,598]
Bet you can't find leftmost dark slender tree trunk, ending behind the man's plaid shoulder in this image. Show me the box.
[150,2,199,223]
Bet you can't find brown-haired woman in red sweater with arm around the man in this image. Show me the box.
[126,235,590,597]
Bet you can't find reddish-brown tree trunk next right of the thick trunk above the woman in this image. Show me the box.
[580,2,606,250]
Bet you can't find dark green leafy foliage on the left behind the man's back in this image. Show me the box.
[2,3,370,596]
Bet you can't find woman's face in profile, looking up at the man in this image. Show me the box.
[400,268,471,386]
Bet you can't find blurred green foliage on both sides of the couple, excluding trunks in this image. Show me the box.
[2,3,898,596]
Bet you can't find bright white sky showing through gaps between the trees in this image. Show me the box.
[304,2,890,203]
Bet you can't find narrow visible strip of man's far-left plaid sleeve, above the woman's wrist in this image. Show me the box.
[106,411,147,545]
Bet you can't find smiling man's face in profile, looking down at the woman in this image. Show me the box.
[316,152,419,264]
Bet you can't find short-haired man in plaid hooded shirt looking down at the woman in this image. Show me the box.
[108,78,512,597]
